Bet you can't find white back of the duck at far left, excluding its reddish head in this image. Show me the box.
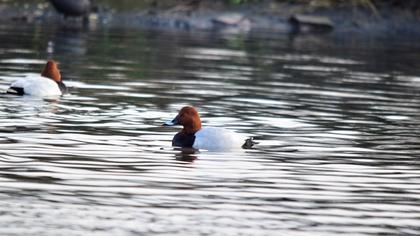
[10,75,62,96]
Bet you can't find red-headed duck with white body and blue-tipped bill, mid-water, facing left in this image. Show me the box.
[163,106,256,151]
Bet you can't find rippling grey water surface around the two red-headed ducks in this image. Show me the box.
[0,25,420,235]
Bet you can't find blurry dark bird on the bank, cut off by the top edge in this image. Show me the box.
[50,0,90,17]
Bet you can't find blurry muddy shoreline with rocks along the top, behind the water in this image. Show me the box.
[0,2,420,38]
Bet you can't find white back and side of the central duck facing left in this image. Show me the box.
[193,127,246,151]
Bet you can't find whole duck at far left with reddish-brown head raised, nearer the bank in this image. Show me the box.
[7,60,68,97]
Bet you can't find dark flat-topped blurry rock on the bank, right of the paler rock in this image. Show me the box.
[289,14,334,33]
